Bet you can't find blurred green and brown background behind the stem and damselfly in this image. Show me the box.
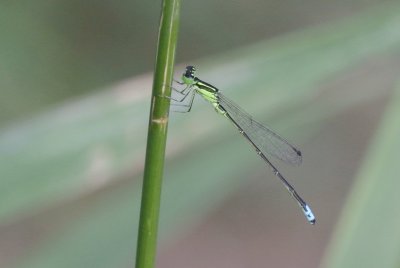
[0,0,400,268]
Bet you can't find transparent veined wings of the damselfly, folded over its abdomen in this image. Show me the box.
[218,92,302,165]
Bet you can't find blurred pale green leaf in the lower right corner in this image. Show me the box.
[323,83,400,268]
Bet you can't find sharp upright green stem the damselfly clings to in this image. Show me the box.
[136,0,180,268]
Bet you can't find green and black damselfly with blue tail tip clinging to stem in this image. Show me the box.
[171,66,315,224]
